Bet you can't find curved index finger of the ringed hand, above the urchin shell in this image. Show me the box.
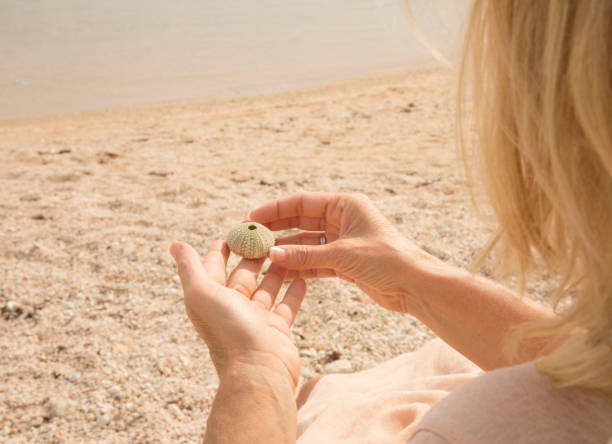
[249,193,338,229]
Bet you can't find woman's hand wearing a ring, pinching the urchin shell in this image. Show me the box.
[249,193,445,314]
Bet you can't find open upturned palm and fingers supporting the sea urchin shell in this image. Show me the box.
[170,241,306,390]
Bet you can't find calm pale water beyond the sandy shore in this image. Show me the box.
[0,0,463,119]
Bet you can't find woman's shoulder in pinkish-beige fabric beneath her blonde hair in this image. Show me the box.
[409,363,612,444]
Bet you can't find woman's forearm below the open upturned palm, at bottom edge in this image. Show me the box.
[204,360,297,444]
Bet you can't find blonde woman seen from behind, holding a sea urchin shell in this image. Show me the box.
[171,0,612,444]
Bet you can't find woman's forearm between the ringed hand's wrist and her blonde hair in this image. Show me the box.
[413,260,554,370]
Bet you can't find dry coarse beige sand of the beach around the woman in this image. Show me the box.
[0,70,546,443]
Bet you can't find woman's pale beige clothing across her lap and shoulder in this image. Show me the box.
[297,339,612,444]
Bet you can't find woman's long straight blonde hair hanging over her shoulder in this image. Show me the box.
[458,0,612,400]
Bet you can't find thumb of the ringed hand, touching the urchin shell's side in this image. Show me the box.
[270,245,338,270]
